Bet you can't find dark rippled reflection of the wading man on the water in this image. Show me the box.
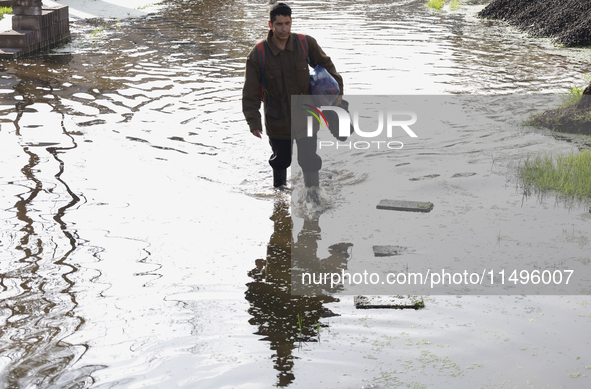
[245,201,352,387]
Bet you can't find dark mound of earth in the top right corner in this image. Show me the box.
[478,0,591,46]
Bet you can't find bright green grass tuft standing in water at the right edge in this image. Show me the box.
[518,150,591,199]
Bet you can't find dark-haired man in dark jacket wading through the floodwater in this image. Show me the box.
[242,3,343,188]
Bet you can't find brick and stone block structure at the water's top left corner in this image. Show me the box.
[0,0,70,59]
